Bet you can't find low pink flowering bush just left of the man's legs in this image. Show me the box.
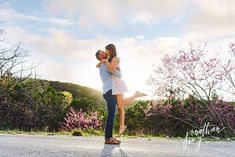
[60,107,101,131]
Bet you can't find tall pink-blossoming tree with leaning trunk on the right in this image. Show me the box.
[149,45,234,136]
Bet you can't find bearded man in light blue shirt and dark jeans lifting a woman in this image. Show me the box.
[96,50,122,144]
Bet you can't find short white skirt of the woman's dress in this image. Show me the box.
[112,58,128,95]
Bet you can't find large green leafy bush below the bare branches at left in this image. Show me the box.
[0,79,70,131]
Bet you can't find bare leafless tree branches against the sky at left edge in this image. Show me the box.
[0,25,34,100]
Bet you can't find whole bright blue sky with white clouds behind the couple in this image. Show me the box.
[0,0,235,98]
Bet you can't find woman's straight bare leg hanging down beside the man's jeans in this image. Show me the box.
[116,94,125,130]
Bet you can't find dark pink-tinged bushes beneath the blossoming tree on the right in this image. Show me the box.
[145,96,235,137]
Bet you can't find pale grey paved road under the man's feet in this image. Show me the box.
[0,134,235,157]
